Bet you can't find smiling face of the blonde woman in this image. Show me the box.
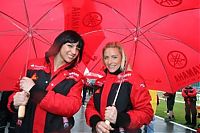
[103,48,122,73]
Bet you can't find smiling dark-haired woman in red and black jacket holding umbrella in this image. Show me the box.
[8,30,84,133]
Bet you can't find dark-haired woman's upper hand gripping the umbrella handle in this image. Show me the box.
[19,77,35,92]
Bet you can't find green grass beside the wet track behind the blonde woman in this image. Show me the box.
[156,92,200,129]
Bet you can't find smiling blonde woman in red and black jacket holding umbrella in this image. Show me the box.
[85,42,153,133]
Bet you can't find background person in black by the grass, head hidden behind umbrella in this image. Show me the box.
[163,92,176,122]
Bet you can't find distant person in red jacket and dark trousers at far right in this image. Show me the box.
[182,86,197,128]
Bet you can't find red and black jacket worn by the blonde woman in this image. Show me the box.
[85,72,153,132]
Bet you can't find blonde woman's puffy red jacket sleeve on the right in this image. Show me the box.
[127,86,154,128]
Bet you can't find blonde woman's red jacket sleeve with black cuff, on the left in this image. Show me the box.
[85,96,101,127]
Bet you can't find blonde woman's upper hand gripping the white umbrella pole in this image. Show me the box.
[105,106,117,124]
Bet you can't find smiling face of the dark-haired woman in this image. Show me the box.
[60,42,80,63]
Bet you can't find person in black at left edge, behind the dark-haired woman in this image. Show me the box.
[0,91,17,133]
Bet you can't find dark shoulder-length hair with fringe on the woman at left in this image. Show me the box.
[45,30,84,68]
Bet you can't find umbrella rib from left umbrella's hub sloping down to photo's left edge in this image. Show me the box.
[0,34,28,72]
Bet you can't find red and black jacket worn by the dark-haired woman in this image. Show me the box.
[8,58,83,133]
